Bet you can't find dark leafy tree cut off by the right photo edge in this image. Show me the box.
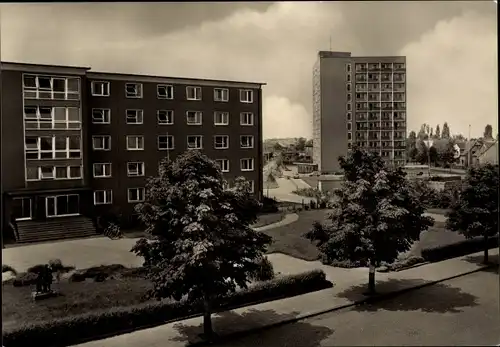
[446,164,499,263]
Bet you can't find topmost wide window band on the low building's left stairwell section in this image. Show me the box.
[23,74,80,100]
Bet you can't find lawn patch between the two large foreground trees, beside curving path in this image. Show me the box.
[265,210,329,261]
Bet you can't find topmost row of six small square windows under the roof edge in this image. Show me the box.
[91,81,254,104]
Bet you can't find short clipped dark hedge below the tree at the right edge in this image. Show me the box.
[422,236,498,261]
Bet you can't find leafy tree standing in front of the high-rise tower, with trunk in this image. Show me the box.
[305,148,433,294]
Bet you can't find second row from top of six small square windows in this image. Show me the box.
[92,108,254,126]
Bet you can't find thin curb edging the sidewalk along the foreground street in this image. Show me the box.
[186,264,498,347]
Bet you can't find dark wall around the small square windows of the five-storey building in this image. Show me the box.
[87,75,262,212]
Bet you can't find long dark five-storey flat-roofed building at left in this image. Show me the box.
[1,62,263,241]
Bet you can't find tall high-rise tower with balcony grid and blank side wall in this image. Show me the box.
[313,51,406,174]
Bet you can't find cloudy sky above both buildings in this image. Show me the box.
[0,1,498,138]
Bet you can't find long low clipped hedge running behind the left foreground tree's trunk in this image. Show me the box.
[3,270,332,347]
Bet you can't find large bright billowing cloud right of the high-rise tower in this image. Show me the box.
[401,12,498,136]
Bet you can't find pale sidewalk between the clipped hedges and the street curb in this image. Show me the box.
[73,249,498,347]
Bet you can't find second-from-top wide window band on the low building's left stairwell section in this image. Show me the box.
[24,106,81,130]
